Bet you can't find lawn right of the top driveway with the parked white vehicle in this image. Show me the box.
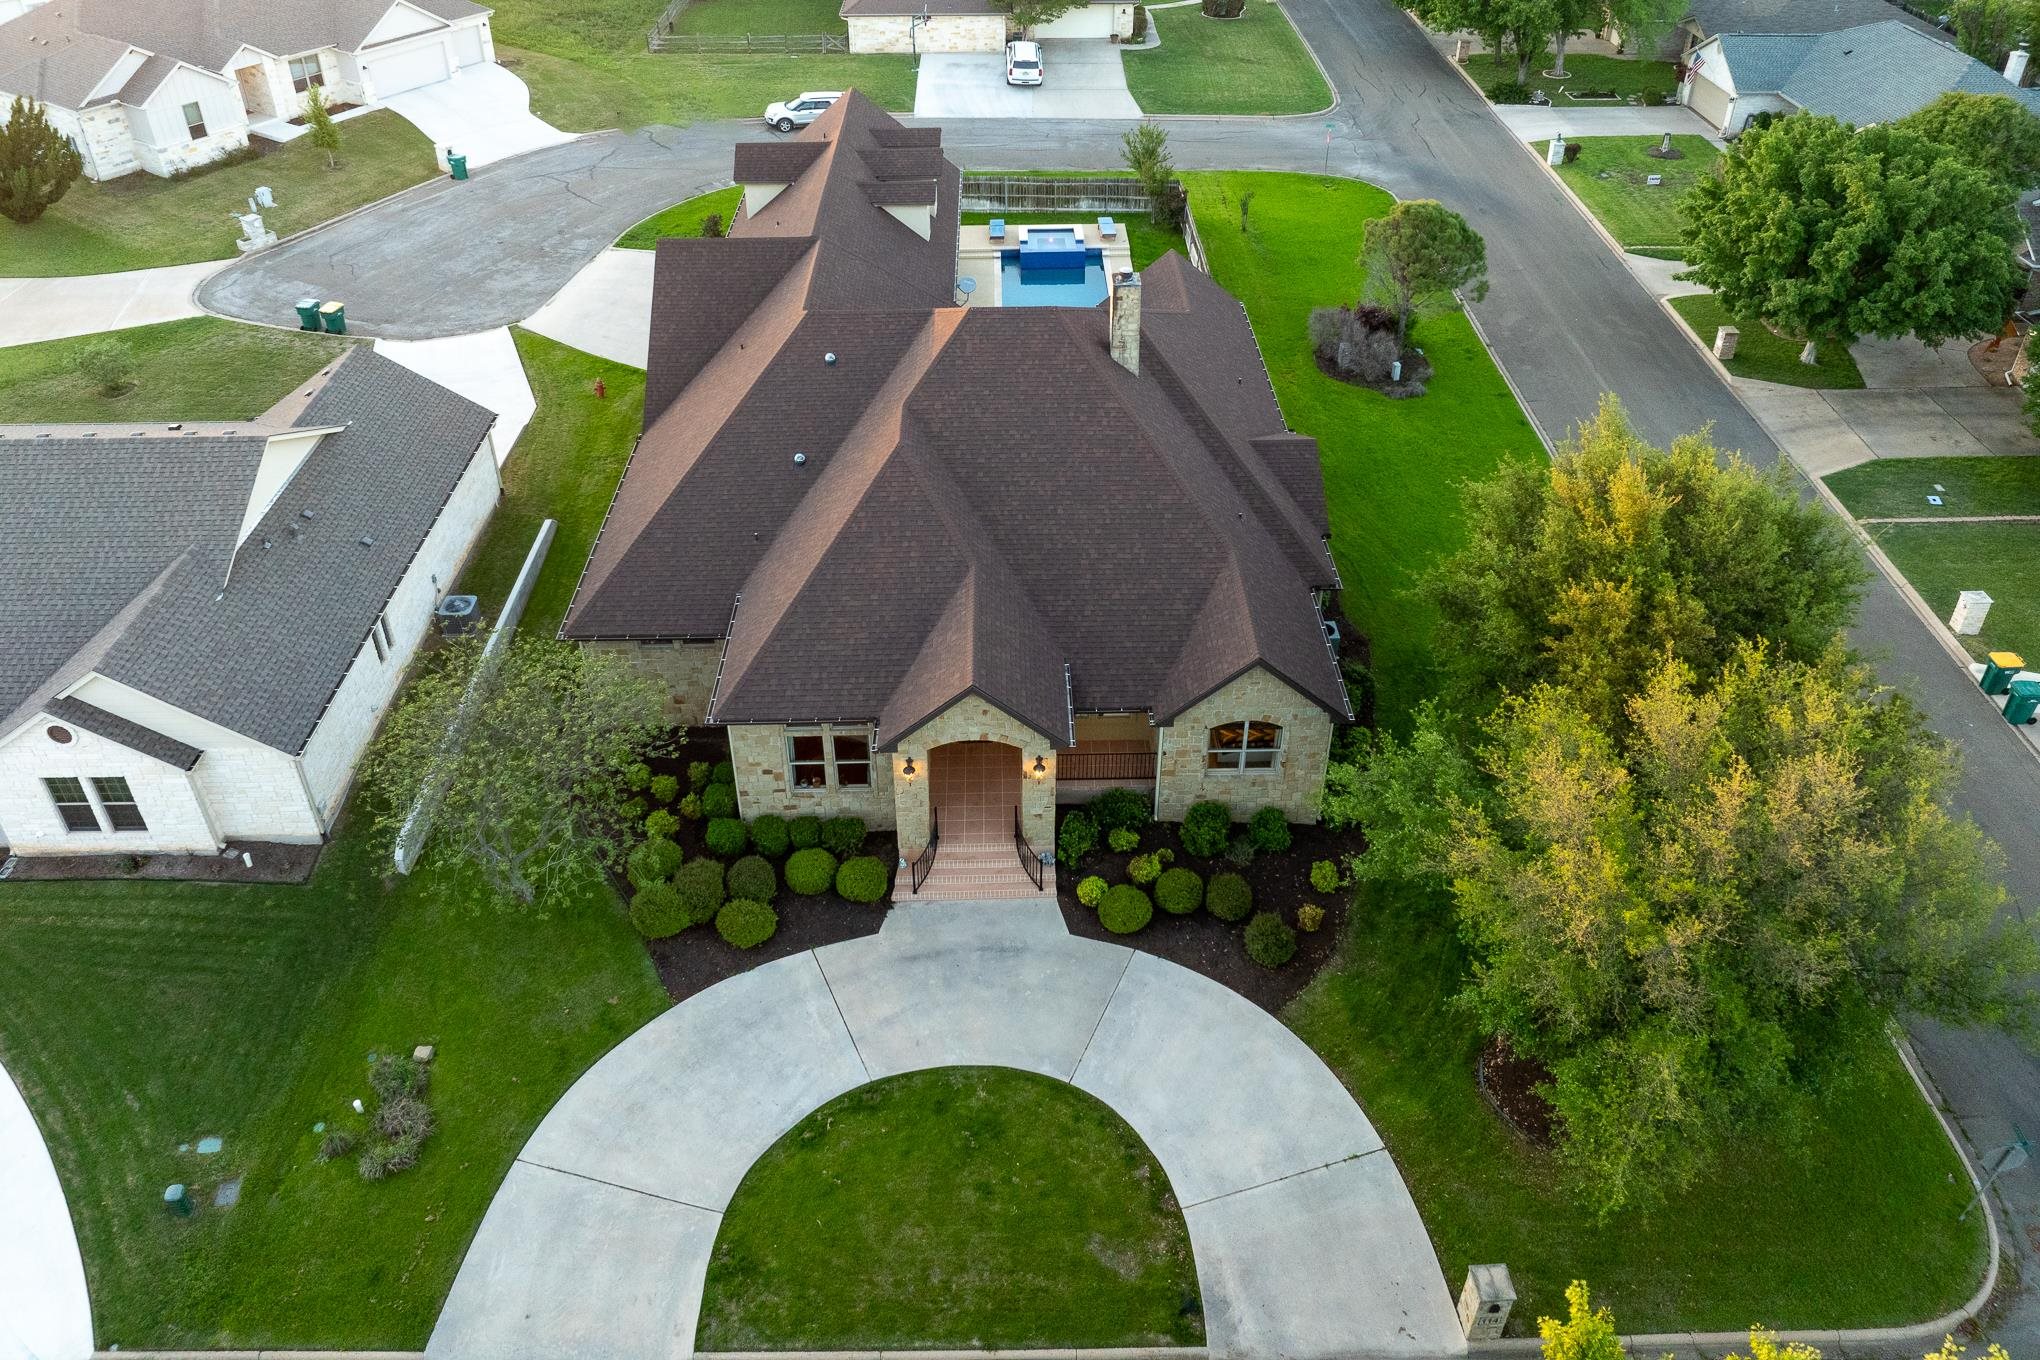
[1126,0,1332,114]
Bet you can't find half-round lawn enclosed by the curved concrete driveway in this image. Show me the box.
[698,1066,1199,1352]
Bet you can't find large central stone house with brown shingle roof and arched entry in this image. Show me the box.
[561,92,1350,893]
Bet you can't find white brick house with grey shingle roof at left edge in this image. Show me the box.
[0,347,498,854]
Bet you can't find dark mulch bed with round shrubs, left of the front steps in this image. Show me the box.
[628,728,900,1001]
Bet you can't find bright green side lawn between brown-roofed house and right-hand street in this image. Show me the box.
[1183,171,1544,726]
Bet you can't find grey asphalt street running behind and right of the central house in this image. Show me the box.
[200,0,2040,1354]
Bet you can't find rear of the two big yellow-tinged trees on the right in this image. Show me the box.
[1422,398,1865,728]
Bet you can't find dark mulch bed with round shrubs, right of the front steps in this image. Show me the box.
[1055,807,1363,1015]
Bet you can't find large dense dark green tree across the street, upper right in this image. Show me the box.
[1683,112,2024,359]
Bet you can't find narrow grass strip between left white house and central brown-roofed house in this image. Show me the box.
[457,328,645,636]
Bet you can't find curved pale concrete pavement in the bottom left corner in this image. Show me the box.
[0,1068,92,1360]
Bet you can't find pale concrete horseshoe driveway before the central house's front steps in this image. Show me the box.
[426,901,1467,1360]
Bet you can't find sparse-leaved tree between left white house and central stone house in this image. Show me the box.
[363,638,665,905]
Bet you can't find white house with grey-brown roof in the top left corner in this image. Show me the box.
[0,0,496,179]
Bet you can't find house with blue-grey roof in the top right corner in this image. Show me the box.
[1681,18,2040,137]
